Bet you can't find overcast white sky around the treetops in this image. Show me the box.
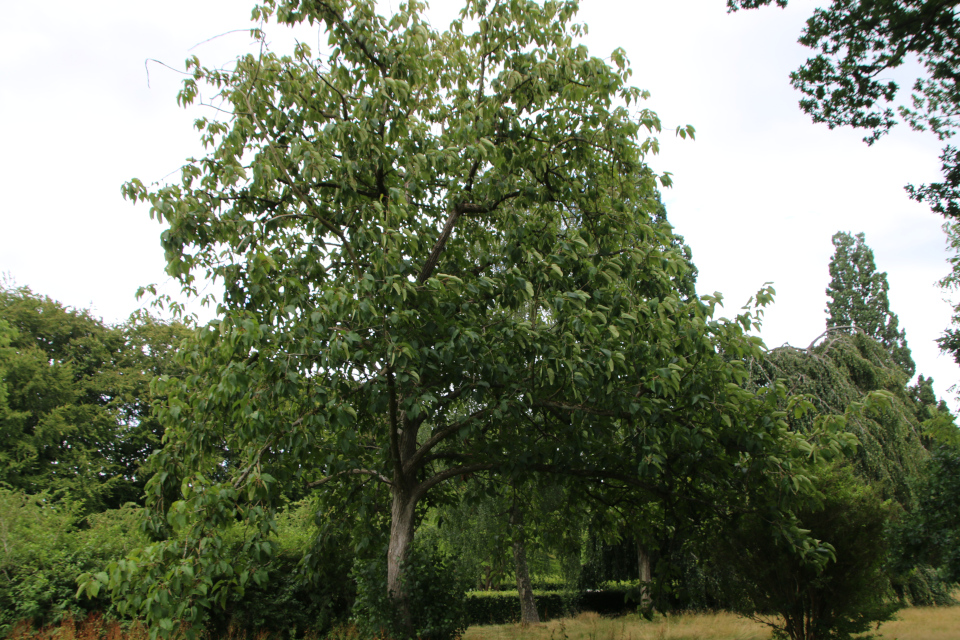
[0,0,960,404]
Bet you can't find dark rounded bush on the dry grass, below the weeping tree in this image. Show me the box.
[725,466,898,640]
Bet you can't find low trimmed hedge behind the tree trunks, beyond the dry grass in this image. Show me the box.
[467,589,637,625]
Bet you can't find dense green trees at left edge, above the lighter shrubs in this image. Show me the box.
[0,288,187,512]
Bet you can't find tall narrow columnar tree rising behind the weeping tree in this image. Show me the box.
[827,231,916,376]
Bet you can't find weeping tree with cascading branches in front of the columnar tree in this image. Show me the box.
[757,330,957,605]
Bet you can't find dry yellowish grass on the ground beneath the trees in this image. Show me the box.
[463,607,960,640]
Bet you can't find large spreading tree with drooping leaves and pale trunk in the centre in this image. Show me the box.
[82,0,856,636]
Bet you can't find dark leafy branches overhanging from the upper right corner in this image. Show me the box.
[727,0,960,218]
